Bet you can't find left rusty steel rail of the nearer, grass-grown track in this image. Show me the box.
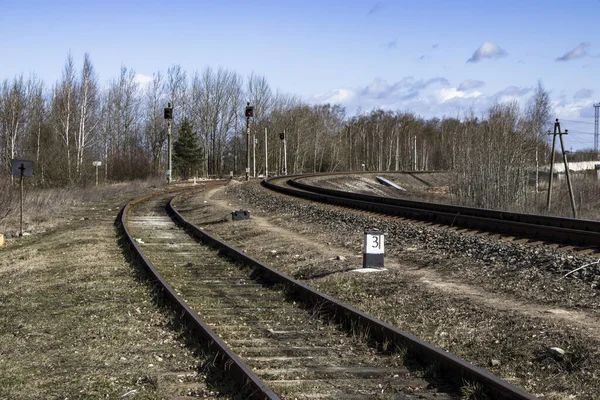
[119,188,279,400]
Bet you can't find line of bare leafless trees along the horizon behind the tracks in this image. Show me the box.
[0,54,552,211]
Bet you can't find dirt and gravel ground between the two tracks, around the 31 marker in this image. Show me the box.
[177,183,600,399]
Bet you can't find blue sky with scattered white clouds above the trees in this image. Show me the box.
[0,0,600,149]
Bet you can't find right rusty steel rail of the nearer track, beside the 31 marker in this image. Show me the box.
[167,194,536,400]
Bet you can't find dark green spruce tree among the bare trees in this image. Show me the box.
[173,118,204,180]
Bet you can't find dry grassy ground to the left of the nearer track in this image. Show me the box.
[0,183,232,400]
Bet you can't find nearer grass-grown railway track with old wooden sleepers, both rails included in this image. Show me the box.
[121,184,534,399]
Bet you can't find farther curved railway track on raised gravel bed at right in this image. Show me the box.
[262,172,600,249]
